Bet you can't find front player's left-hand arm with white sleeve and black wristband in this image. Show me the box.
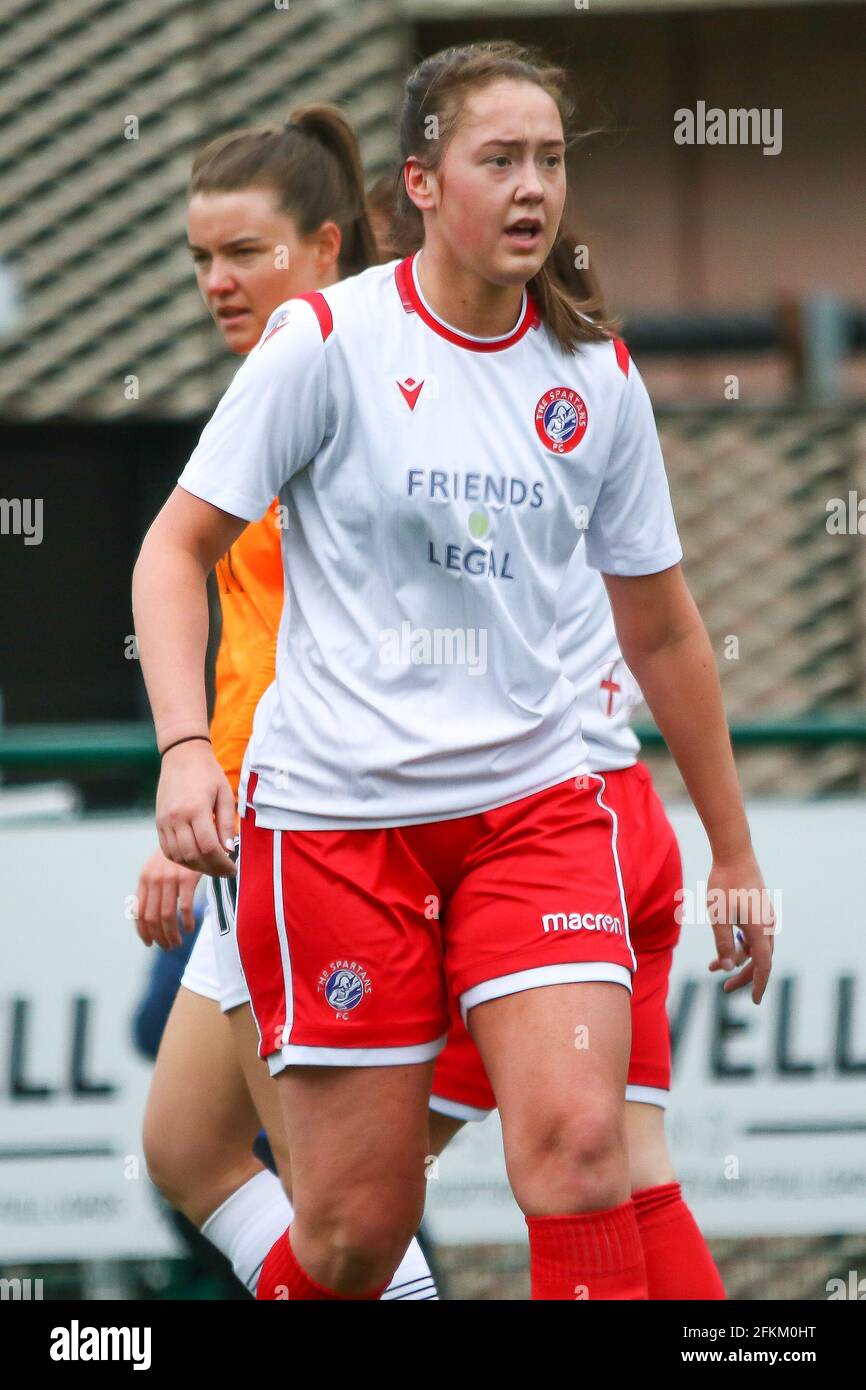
[133,300,328,876]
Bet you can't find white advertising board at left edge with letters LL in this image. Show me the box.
[0,817,177,1265]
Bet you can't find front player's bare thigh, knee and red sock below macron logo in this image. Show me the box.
[468,981,646,1300]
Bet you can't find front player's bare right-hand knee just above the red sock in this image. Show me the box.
[507,1099,627,1215]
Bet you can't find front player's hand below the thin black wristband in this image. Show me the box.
[156,739,238,878]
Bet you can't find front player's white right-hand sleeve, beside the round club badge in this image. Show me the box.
[585,361,683,575]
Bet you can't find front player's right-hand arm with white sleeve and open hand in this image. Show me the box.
[587,347,773,1004]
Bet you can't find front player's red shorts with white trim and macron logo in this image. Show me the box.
[238,774,635,1073]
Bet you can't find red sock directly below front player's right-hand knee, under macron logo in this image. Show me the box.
[527,1201,646,1300]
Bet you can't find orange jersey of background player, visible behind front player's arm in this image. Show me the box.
[210,499,282,801]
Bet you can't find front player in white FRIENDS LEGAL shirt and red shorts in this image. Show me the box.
[135,44,770,1300]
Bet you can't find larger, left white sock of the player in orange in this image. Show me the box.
[202,1168,295,1297]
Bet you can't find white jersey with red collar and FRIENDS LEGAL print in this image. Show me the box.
[179,253,681,830]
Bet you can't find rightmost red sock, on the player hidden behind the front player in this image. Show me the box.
[632,1183,726,1300]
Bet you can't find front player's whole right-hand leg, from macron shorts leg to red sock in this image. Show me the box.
[445,778,646,1300]
